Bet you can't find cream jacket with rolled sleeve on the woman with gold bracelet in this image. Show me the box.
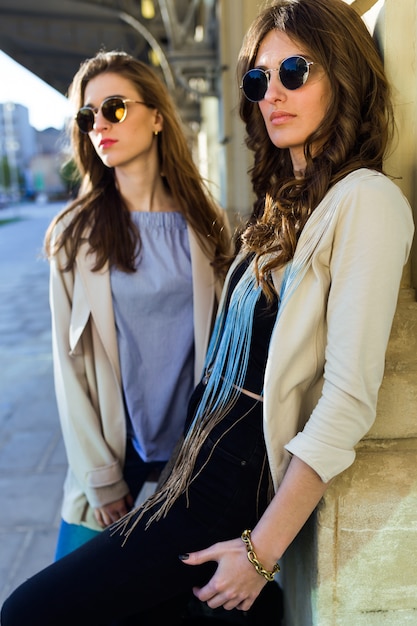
[221,169,414,488]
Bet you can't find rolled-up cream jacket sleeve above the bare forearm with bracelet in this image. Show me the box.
[285,174,414,482]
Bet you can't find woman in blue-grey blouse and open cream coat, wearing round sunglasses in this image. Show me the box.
[37,52,230,558]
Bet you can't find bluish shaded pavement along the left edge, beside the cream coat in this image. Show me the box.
[0,204,66,604]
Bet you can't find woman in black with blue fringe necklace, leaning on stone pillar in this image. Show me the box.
[3,0,414,626]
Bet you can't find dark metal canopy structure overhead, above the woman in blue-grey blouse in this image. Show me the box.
[0,0,219,120]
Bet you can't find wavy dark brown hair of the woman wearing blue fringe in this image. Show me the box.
[237,0,394,296]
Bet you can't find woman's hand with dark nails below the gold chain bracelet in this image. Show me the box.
[180,539,266,611]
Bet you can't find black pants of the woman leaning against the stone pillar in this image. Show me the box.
[1,395,269,626]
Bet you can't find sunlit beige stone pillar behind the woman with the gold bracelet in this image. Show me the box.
[282,0,417,626]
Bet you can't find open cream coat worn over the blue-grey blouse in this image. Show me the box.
[50,214,226,530]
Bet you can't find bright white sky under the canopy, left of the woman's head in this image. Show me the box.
[0,50,71,130]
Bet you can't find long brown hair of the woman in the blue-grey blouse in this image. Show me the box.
[45,51,230,276]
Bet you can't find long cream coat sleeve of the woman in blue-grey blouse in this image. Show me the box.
[50,227,128,507]
